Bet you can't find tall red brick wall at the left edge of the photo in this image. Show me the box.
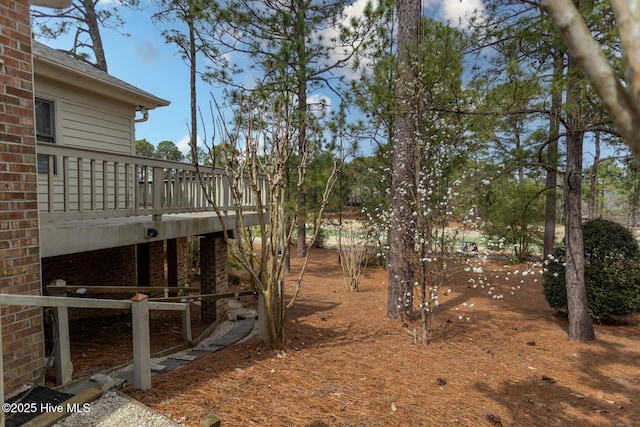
[0,0,44,394]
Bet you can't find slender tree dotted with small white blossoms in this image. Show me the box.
[371,19,480,344]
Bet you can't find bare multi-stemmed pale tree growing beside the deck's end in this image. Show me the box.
[198,103,337,347]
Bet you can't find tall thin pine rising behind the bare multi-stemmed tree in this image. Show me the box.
[194,0,386,256]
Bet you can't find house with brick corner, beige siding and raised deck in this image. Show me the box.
[0,0,266,393]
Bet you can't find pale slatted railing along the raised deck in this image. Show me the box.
[38,143,268,222]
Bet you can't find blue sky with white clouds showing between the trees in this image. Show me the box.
[32,0,482,153]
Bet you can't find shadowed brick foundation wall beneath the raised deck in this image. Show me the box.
[42,245,137,286]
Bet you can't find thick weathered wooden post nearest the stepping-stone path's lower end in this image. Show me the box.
[131,294,151,390]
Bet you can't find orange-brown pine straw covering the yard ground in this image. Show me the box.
[120,250,640,427]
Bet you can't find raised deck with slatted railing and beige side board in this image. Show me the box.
[38,143,268,257]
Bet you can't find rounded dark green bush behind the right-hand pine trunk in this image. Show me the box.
[544,218,640,322]
